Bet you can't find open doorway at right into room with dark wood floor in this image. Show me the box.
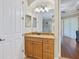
[61,0,79,59]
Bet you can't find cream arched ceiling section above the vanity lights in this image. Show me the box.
[28,0,54,11]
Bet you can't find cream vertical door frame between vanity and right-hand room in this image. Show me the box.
[54,0,62,59]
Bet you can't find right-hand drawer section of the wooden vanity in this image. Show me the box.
[43,39,54,59]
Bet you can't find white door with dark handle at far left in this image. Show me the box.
[0,0,22,59]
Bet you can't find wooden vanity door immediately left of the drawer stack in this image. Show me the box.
[33,42,43,59]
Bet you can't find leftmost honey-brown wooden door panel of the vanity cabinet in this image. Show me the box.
[25,38,33,57]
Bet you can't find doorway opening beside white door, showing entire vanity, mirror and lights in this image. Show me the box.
[24,0,55,59]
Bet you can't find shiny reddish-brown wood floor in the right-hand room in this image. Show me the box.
[61,36,79,59]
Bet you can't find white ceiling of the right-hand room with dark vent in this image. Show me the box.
[61,0,79,16]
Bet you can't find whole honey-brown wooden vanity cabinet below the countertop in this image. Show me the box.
[25,36,54,59]
